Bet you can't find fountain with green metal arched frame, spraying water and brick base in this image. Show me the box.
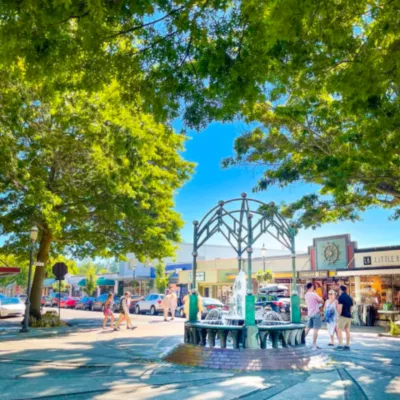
[165,193,327,370]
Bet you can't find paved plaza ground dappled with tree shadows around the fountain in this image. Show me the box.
[0,310,400,400]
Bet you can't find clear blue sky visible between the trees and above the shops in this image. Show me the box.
[174,122,400,251]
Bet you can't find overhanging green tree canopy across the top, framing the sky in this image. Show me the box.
[0,0,400,226]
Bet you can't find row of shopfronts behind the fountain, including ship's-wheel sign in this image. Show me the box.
[178,234,400,325]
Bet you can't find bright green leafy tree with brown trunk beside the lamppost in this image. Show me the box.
[0,80,192,318]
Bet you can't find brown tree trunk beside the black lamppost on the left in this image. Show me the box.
[29,230,52,319]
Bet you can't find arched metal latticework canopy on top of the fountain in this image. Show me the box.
[192,193,296,293]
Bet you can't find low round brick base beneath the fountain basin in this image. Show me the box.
[165,344,329,371]
